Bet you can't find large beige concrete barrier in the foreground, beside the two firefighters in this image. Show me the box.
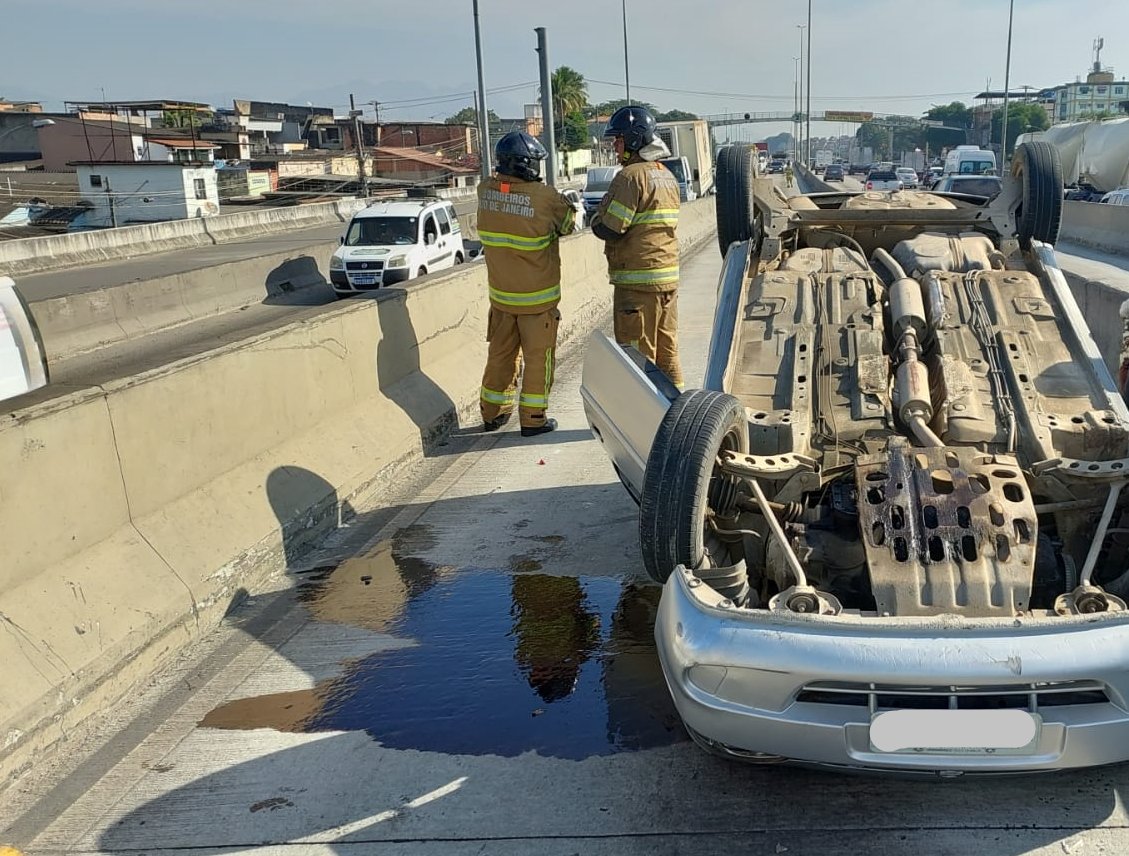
[0,199,714,775]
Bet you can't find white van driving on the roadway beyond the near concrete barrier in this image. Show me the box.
[330,198,466,297]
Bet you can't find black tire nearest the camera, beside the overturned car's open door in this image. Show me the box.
[639,390,749,583]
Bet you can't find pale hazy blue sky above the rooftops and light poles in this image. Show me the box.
[0,0,1129,136]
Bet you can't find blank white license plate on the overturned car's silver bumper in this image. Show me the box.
[870,710,1042,754]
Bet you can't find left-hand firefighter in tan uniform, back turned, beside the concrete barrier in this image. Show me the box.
[479,131,576,437]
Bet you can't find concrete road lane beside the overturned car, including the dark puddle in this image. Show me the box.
[0,238,1129,856]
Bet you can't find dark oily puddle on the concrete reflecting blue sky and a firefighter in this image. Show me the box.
[200,539,686,760]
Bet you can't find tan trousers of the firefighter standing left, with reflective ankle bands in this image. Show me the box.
[479,306,561,428]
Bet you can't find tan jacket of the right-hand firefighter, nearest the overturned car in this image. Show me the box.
[594,160,679,291]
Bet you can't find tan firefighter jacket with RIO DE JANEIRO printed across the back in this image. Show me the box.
[479,173,576,315]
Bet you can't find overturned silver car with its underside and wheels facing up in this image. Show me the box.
[581,142,1129,775]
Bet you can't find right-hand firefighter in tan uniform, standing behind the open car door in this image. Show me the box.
[592,106,682,388]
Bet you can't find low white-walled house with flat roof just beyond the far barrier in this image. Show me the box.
[71,160,219,228]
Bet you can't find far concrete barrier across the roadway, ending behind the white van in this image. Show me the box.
[0,199,366,278]
